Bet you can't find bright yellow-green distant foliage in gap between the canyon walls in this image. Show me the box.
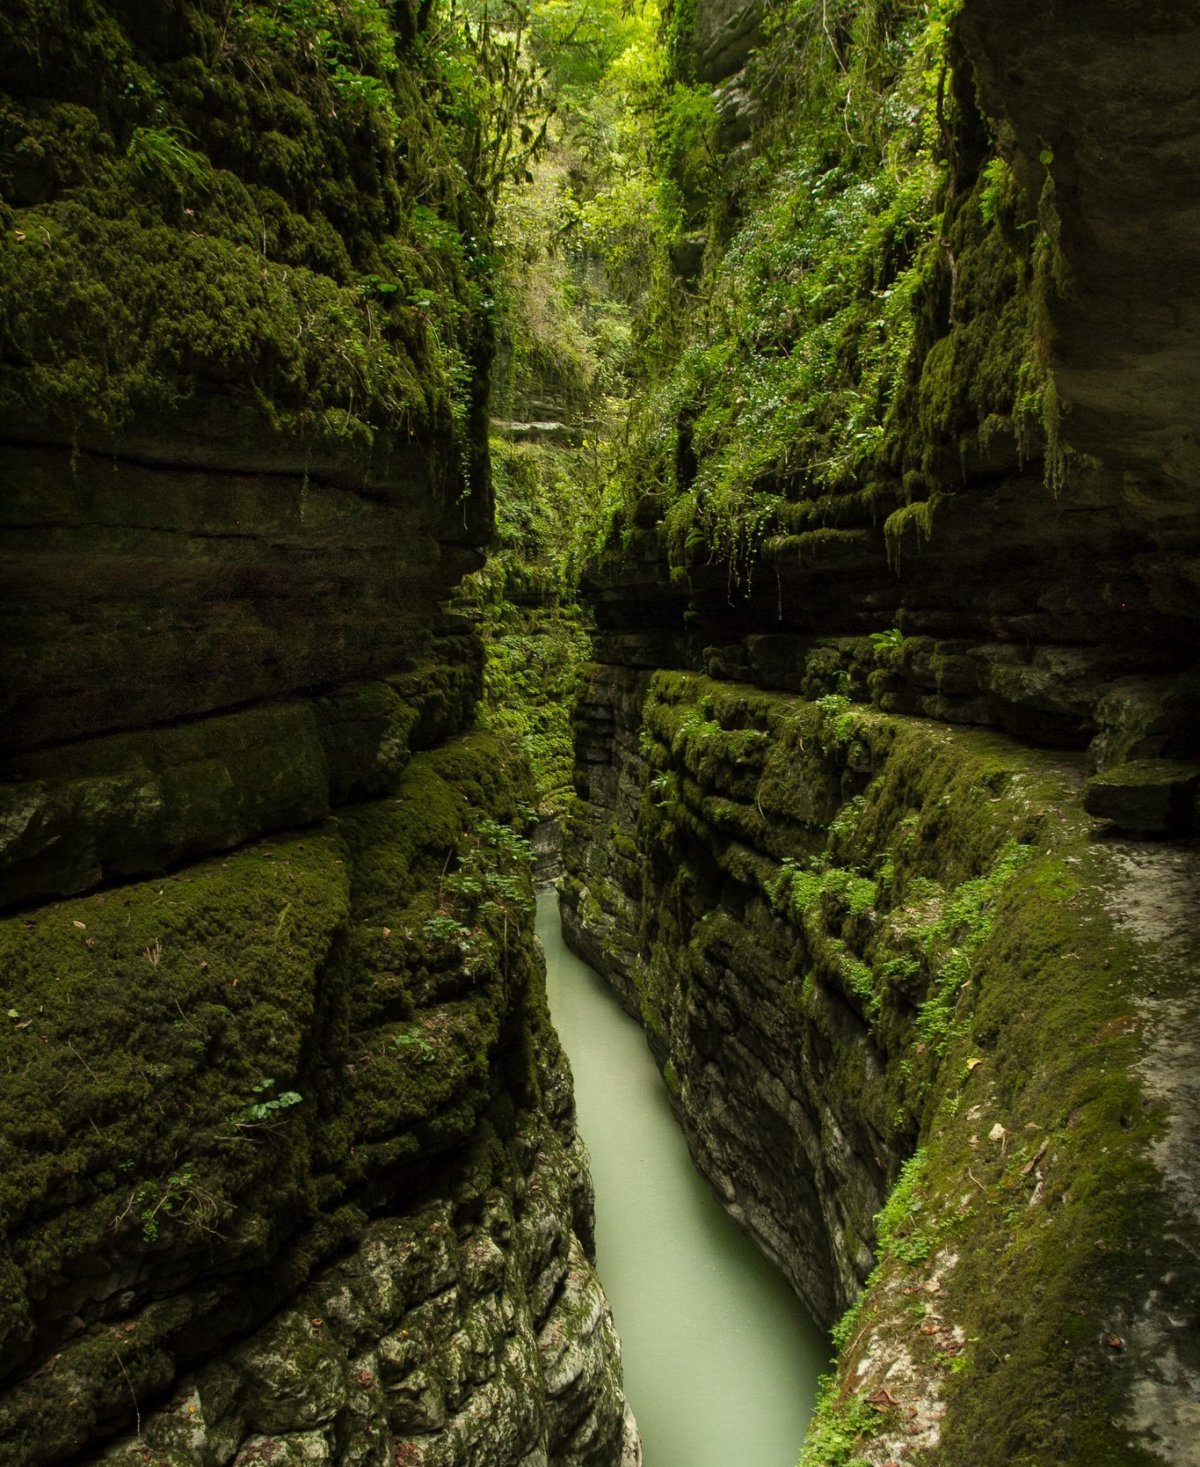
[454,0,663,814]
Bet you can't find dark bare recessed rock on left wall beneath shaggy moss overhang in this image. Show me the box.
[0,445,486,750]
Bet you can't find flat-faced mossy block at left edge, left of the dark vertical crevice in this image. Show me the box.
[0,835,348,1341]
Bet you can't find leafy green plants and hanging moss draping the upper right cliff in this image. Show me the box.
[583,0,1059,581]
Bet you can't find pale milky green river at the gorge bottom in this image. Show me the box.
[537,892,829,1467]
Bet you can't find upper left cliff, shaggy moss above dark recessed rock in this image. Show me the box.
[0,0,493,798]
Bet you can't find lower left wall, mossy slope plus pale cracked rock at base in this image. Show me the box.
[0,736,637,1467]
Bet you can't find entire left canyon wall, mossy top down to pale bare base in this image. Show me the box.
[0,11,640,1467]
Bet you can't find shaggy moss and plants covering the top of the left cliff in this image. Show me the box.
[0,0,480,447]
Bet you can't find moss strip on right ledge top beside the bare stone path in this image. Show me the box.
[792,736,1185,1464]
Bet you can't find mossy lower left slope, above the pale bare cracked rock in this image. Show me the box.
[0,733,607,1464]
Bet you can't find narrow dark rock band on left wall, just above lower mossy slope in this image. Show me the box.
[0,634,480,907]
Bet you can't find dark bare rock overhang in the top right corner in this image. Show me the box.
[962,0,1200,492]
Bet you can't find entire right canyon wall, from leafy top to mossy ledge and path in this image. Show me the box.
[562,0,1200,1467]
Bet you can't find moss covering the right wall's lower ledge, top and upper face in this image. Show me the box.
[597,672,1194,1467]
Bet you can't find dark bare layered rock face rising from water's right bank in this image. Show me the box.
[560,667,889,1325]
